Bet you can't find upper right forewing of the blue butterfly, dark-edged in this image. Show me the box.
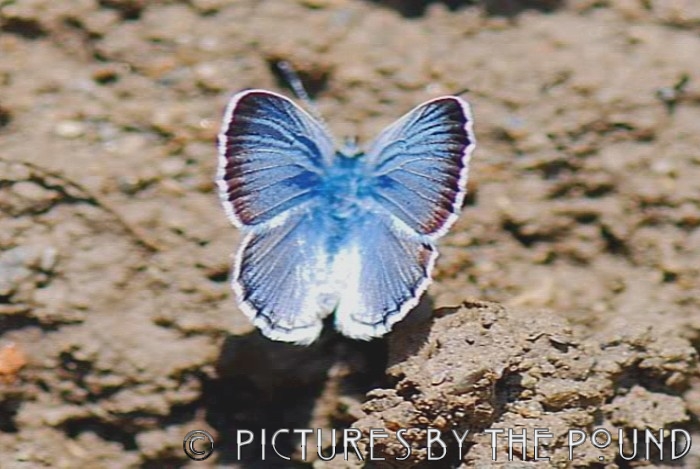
[367,96,475,238]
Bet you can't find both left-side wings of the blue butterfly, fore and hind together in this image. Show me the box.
[217,90,335,343]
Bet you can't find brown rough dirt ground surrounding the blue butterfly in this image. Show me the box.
[0,0,700,468]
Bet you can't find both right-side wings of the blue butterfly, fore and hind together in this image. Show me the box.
[336,96,474,339]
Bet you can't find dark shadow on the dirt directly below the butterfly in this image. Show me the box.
[202,324,387,462]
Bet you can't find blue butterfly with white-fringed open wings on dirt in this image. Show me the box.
[217,90,475,344]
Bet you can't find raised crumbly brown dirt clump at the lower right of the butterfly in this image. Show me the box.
[353,301,697,467]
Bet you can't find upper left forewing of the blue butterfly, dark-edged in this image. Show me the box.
[216,90,335,227]
